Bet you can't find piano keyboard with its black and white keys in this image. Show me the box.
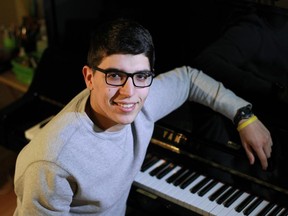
[134,154,288,216]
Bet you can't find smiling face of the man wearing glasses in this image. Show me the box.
[83,54,150,130]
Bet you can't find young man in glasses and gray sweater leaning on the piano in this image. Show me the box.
[14,19,272,216]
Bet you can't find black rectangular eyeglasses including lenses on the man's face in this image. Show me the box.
[92,67,155,88]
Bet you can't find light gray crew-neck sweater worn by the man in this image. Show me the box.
[14,67,248,216]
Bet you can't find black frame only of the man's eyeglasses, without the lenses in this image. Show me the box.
[91,66,155,88]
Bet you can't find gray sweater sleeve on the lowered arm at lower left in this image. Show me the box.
[14,161,76,216]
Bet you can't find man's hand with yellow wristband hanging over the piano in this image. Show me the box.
[239,119,273,170]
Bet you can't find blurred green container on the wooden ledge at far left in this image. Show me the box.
[11,59,35,85]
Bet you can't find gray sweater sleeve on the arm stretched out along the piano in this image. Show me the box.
[145,66,249,121]
